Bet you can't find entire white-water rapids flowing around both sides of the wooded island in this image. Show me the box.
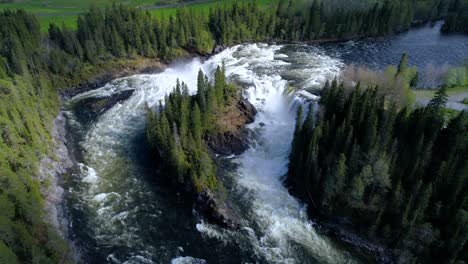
[69,44,357,263]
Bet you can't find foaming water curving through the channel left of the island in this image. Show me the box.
[63,59,229,263]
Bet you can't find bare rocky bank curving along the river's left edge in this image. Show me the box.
[37,58,166,263]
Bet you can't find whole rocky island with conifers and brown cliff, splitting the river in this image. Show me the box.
[146,67,257,227]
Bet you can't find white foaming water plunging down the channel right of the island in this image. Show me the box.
[204,45,353,263]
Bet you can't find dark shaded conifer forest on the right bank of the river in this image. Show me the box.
[288,81,468,263]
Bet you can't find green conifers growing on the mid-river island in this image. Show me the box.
[146,67,234,193]
